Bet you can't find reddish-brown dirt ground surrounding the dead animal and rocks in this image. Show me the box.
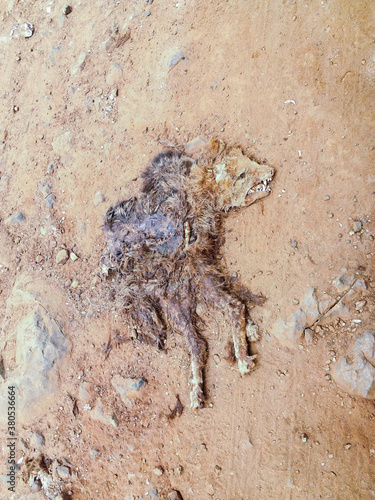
[0,0,375,500]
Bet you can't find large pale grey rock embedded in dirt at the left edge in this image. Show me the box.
[0,275,71,428]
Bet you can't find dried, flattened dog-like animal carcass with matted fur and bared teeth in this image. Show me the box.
[104,141,274,408]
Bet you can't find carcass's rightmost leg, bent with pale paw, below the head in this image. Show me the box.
[203,276,258,375]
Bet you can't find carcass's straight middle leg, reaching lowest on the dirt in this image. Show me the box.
[162,298,207,409]
